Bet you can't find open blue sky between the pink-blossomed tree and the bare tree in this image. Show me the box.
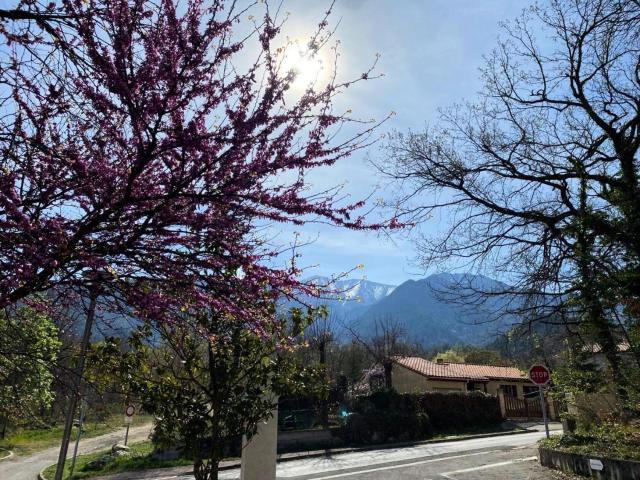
[272,0,528,284]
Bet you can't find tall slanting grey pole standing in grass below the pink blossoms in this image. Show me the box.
[54,281,98,480]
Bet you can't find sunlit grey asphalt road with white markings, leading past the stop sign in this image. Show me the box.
[138,432,567,480]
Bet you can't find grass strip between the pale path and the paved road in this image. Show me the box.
[44,440,198,480]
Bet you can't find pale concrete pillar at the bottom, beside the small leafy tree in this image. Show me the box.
[240,407,278,480]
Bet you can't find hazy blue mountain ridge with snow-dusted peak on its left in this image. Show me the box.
[290,273,517,347]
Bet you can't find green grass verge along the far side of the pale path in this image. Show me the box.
[0,415,152,455]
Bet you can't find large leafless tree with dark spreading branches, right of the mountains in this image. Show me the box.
[377,0,640,392]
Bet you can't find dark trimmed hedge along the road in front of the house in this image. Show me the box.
[343,391,502,444]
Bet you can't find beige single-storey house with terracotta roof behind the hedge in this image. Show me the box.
[391,356,538,398]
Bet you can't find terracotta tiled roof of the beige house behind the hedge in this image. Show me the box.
[393,356,528,381]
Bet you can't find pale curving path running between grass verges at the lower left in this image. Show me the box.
[0,424,151,480]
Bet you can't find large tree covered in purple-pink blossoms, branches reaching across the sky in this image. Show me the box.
[0,0,384,319]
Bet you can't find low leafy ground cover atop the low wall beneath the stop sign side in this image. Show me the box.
[538,423,640,461]
